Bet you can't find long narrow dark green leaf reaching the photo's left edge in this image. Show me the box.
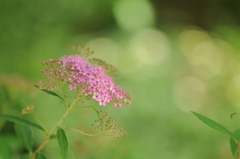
[0,114,45,132]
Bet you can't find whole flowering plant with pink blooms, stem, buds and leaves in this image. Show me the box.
[0,45,131,159]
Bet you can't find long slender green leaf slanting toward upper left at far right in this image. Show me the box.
[192,111,236,140]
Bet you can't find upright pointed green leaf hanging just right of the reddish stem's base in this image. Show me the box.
[57,128,68,159]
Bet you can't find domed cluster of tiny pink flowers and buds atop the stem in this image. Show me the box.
[38,55,131,107]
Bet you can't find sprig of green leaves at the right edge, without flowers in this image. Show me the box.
[192,112,240,159]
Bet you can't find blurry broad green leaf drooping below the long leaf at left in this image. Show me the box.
[14,123,34,152]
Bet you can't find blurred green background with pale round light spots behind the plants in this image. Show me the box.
[0,0,240,159]
